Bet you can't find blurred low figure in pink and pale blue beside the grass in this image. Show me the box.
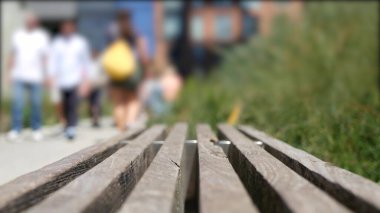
[140,54,183,117]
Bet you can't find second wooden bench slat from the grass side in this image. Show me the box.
[219,124,349,213]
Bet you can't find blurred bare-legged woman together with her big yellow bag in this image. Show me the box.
[102,11,148,131]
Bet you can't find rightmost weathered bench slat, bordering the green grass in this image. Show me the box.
[240,126,380,212]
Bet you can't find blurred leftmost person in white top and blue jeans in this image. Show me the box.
[7,13,49,141]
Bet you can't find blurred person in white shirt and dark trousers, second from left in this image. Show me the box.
[49,20,90,140]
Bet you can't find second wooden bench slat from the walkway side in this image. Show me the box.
[27,125,165,213]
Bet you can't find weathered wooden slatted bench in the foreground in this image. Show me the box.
[0,123,380,213]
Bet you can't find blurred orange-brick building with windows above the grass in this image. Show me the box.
[154,0,303,76]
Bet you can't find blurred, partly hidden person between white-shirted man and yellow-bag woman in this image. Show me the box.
[87,50,107,127]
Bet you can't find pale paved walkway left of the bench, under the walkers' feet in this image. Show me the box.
[0,119,118,185]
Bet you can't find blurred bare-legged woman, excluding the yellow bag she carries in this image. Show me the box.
[105,11,148,130]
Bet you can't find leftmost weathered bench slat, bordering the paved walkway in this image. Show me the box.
[0,128,143,212]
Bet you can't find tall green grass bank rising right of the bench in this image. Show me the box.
[159,2,380,183]
